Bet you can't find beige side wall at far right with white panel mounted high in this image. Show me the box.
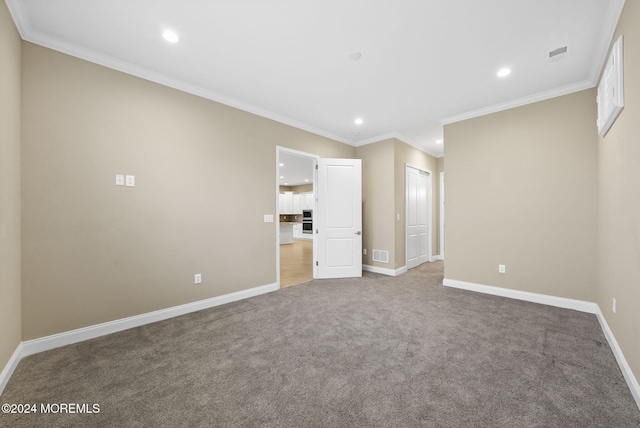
[597,1,640,379]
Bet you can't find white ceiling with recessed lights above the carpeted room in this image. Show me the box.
[6,0,624,156]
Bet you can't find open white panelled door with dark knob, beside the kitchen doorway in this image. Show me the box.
[314,159,362,279]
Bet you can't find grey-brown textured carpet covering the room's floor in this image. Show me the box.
[0,262,640,427]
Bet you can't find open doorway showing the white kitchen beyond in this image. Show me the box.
[276,147,318,288]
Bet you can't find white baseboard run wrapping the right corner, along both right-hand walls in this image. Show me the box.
[442,278,640,409]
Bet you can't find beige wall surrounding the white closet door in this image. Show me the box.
[394,140,439,268]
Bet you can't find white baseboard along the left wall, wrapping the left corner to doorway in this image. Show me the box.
[0,283,279,394]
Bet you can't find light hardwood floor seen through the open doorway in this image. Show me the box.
[280,239,313,288]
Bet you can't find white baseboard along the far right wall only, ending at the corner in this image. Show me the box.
[442,278,598,314]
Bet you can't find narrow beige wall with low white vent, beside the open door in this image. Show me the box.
[356,140,396,270]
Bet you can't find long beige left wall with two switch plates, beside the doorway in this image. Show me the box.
[21,41,355,340]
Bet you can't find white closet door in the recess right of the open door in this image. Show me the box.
[406,165,431,269]
